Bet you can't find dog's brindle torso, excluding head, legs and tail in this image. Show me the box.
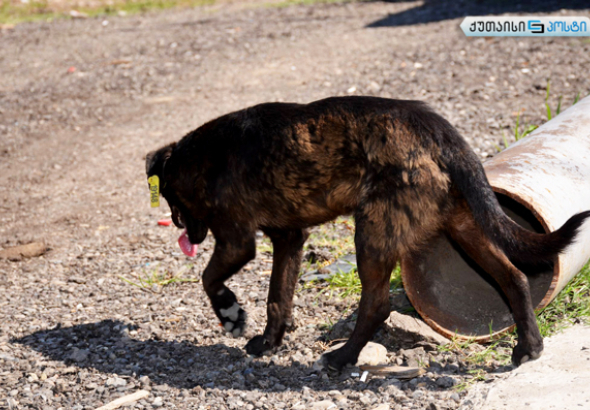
[175,97,461,242]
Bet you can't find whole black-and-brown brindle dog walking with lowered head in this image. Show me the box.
[146,97,590,369]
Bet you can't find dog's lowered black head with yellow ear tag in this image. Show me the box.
[145,142,208,245]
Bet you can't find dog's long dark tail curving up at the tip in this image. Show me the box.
[414,104,590,267]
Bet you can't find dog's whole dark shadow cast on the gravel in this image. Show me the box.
[11,317,512,391]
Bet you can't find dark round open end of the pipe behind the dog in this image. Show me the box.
[402,193,553,338]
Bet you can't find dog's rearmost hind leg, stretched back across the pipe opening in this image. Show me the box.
[449,206,543,366]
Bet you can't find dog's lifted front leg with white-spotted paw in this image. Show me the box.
[203,231,256,337]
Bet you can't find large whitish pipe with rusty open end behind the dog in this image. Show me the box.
[401,97,590,342]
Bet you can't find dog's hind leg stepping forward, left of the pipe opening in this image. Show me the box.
[323,215,397,371]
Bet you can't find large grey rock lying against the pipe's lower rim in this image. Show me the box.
[383,312,450,345]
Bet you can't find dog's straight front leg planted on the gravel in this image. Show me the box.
[246,229,309,355]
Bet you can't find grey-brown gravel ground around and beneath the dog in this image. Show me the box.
[0,2,590,410]
